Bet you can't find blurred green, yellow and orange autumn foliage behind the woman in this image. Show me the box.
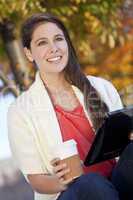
[0,0,133,103]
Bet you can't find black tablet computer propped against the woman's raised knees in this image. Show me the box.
[84,105,133,166]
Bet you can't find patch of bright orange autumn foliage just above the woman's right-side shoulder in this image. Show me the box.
[85,43,133,95]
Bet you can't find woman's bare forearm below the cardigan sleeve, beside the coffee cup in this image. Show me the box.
[28,174,67,194]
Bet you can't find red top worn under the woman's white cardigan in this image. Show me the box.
[54,105,115,177]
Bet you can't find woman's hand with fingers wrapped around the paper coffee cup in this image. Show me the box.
[51,158,72,190]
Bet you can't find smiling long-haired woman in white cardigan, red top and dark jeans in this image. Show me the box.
[8,13,133,200]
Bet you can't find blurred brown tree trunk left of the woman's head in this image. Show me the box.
[0,20,30,90]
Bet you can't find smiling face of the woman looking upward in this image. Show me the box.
[26,22,68,73]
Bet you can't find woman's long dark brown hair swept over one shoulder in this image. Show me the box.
[21,13,108,130]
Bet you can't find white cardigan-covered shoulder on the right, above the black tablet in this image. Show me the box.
[87,75,123,111]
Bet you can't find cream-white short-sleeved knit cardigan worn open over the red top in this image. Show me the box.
[8,73,122,200]
